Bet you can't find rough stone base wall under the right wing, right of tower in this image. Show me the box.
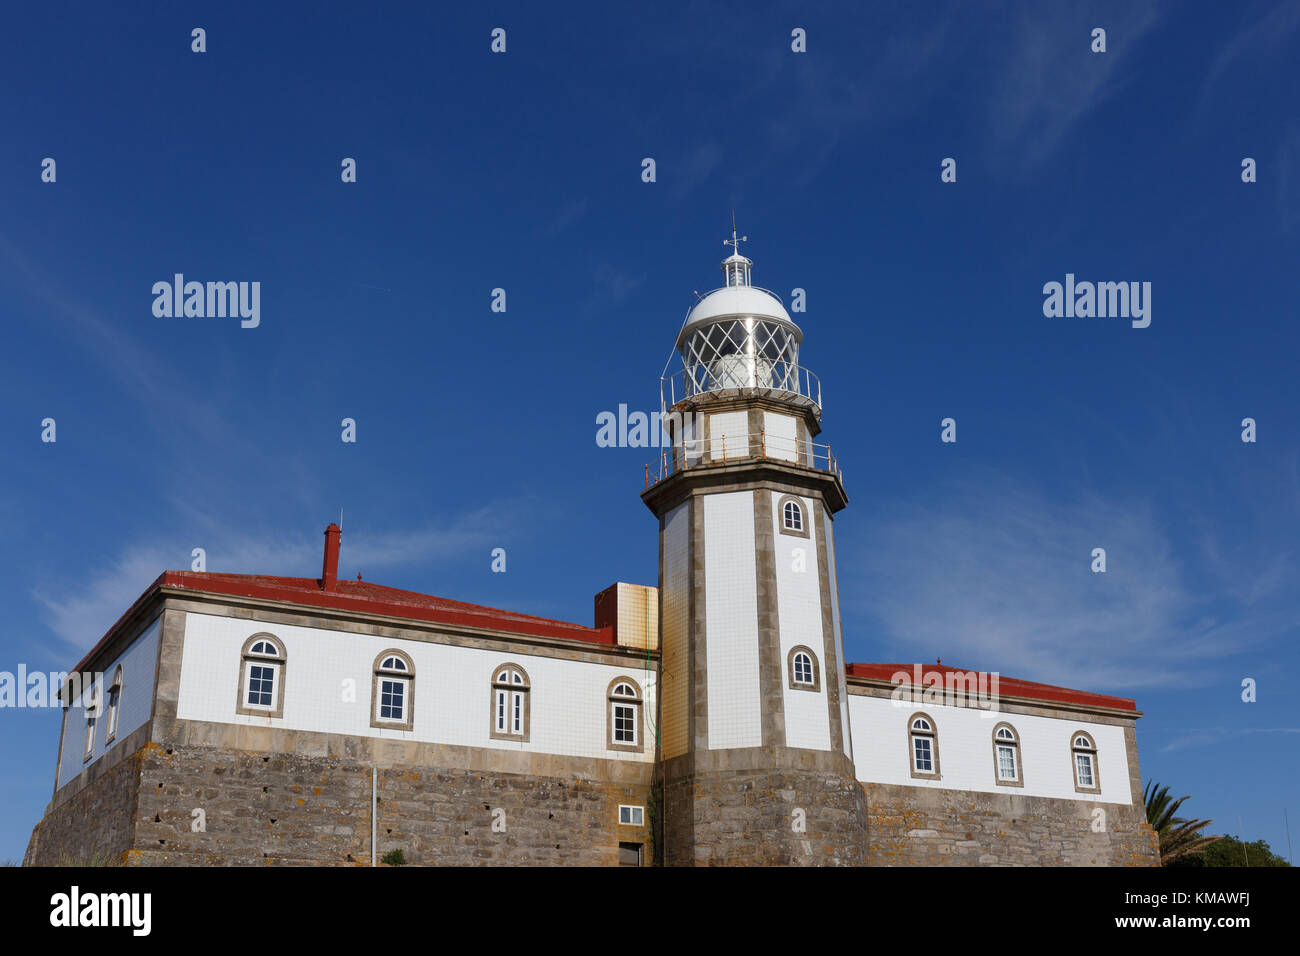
[861,783,1160,866]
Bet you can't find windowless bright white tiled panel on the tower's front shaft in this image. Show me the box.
[698,492,763,750]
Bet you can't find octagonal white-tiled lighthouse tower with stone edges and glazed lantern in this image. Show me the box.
[641,229,867,865]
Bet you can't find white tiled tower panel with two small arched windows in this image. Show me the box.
[767,492,836,750]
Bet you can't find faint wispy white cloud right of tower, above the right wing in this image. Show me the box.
[841,472,1300,691]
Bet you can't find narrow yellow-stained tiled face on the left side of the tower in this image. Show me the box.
[663,502,690,758]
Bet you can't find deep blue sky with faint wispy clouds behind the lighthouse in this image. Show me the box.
[0,3,1300,860]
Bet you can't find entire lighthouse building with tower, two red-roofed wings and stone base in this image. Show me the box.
[26,239,1158,865]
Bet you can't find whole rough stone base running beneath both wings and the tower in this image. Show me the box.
[23,743,1158,866]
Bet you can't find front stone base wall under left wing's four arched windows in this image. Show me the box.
[122,745,653,866]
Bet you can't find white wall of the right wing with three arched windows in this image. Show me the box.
[849,695,1134,804]
